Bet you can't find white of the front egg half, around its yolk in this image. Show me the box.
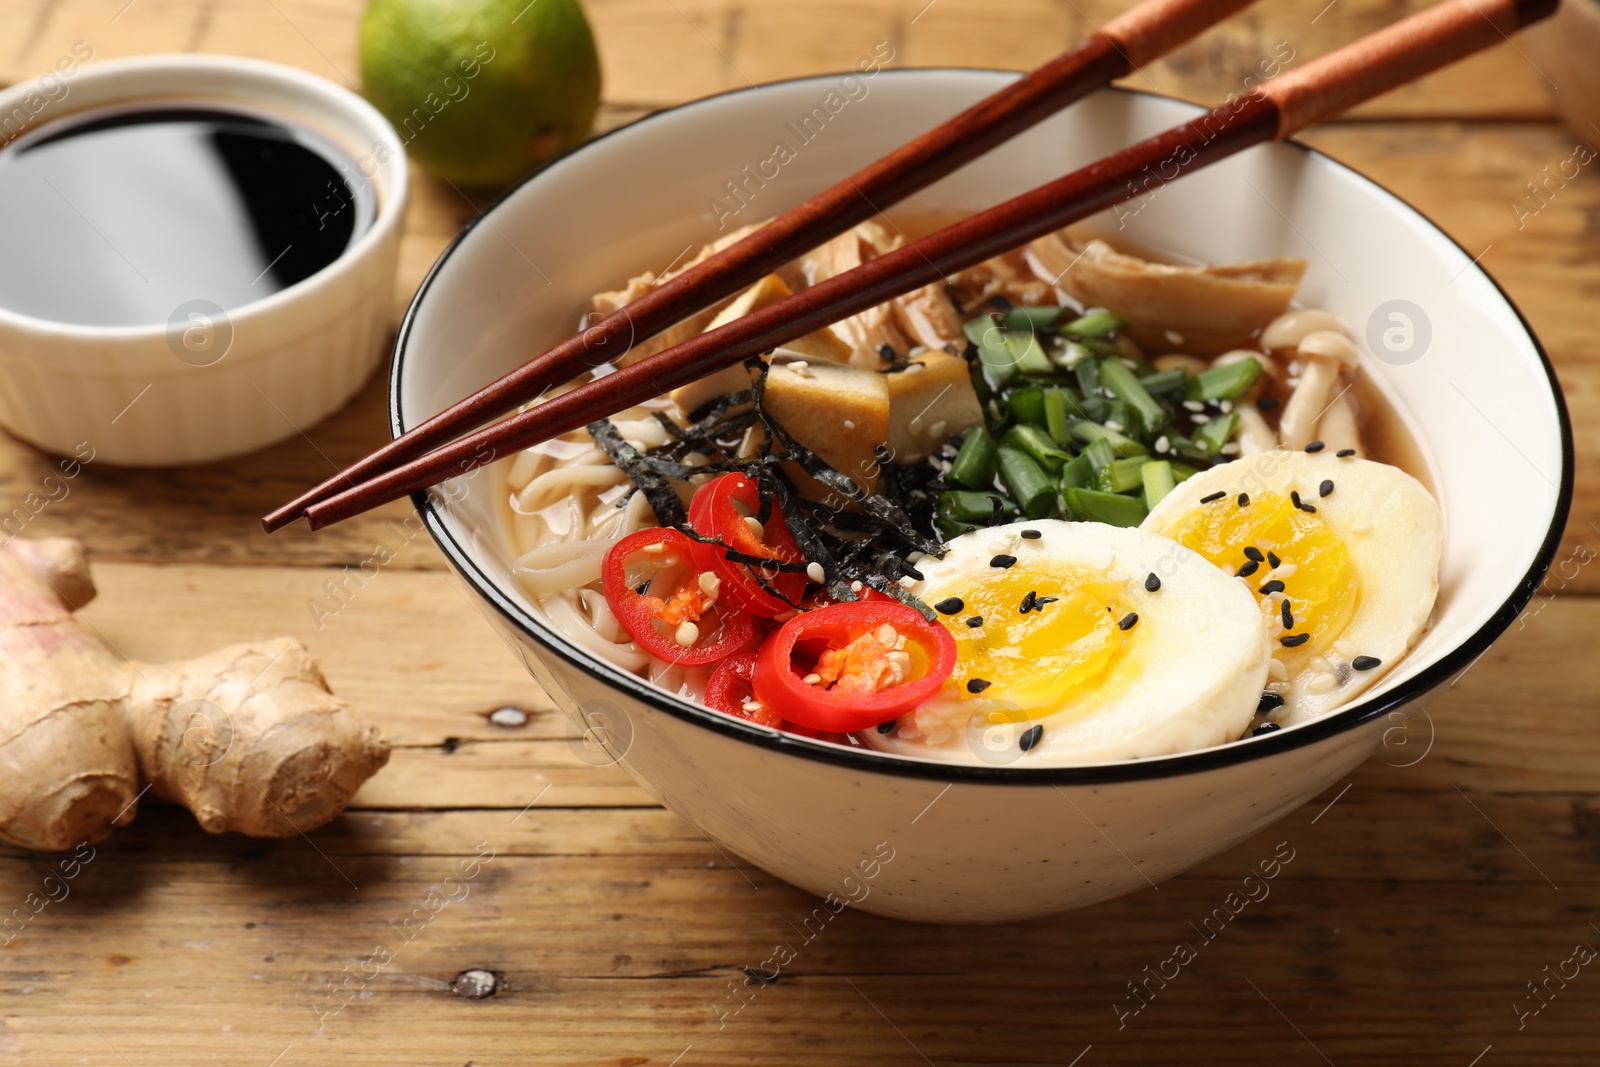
[862,520,1270,766]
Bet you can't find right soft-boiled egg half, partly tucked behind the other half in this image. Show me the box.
[1144,451,1443,725]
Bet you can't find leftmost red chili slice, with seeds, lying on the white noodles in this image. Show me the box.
[600,530,755,667]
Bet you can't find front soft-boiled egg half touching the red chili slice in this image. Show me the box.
[864,520,1272,766]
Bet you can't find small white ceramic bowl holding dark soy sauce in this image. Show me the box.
[0,56,406,466]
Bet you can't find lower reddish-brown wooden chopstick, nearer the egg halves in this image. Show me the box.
[306,0,1557,530]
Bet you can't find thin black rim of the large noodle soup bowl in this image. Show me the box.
[389,67,1574,785]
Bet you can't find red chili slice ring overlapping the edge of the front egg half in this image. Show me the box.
[752,600,955,733]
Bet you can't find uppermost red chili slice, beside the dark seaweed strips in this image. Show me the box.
[690,474,806,619]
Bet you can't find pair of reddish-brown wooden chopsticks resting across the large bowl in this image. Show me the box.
[262,0,1557,531]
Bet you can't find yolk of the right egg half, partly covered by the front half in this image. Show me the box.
[1157,493,1362,664]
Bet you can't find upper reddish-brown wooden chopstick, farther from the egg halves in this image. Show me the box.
[261,0,1253,533]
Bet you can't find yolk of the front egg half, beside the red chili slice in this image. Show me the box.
[941,561,1141,715]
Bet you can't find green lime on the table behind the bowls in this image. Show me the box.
[362,0,600,187]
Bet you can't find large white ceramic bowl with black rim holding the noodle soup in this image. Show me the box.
[392,70,1571,921]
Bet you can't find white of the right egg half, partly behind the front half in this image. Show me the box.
[1142,450,1443,726]
